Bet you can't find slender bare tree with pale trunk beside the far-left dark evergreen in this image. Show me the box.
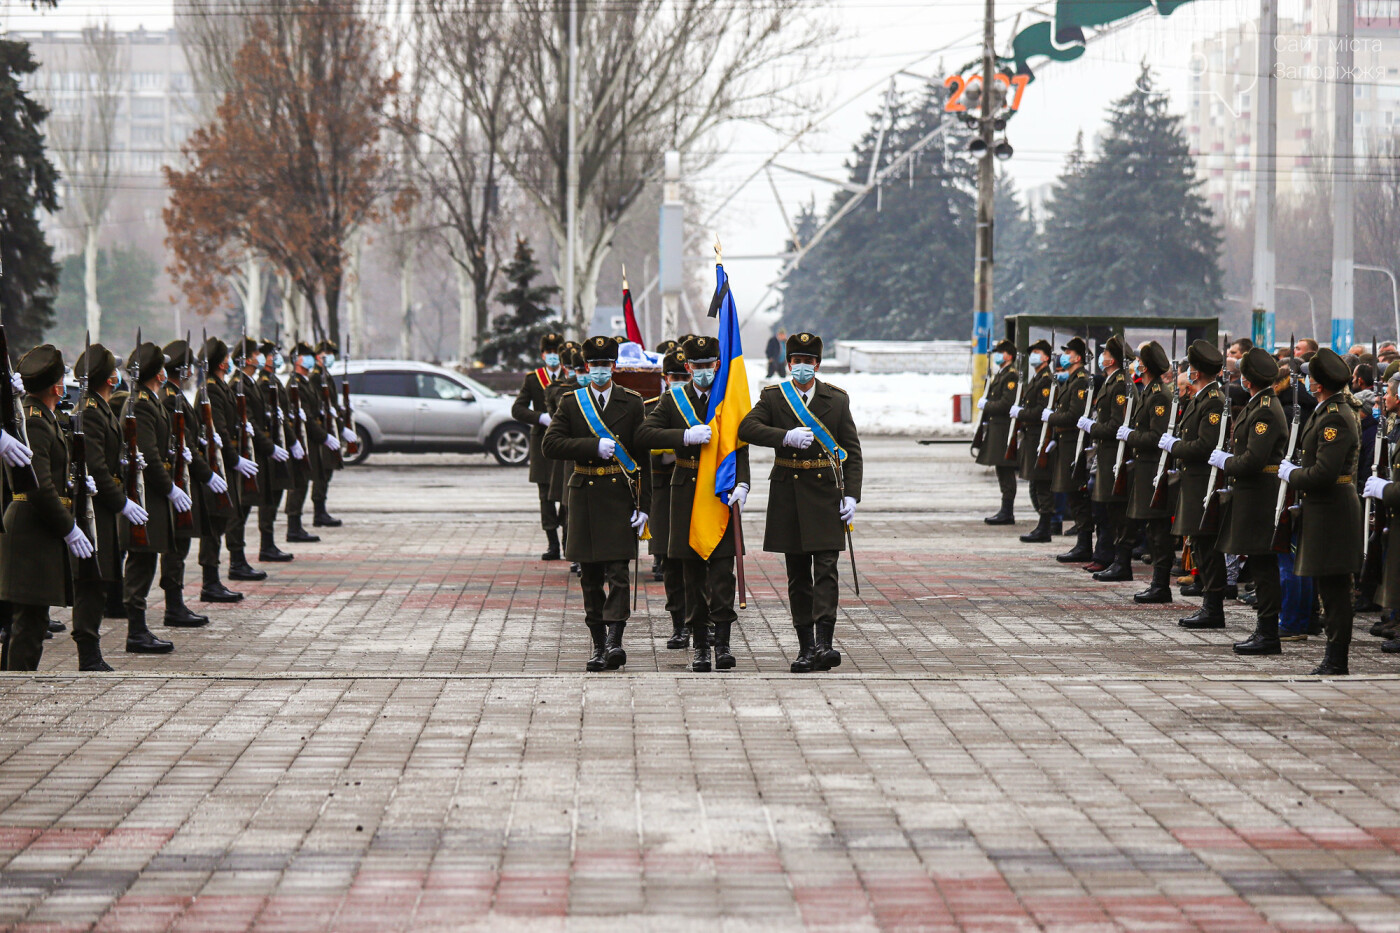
[38,22,126,340]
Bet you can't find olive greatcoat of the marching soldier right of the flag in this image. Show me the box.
[739,380,865,553]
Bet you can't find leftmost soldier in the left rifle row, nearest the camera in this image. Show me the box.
[0,343,92,671]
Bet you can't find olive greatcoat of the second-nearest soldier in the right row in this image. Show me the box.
[1218,387,1288,555]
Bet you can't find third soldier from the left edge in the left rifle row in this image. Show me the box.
[119,337,186,654]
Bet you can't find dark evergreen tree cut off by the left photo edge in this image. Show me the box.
[0,39,59,357]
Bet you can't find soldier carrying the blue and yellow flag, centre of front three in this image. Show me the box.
[638,336,749,672]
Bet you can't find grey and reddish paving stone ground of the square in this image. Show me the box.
[0,438,1400,932]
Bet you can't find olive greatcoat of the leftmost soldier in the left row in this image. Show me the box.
[0,395,73,605]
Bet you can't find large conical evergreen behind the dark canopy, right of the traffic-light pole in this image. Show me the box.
[1044,66,1224,317]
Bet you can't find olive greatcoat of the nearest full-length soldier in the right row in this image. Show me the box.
[1288,392,1361,577]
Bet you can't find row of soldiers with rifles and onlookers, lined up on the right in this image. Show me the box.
[980,330,1400,675]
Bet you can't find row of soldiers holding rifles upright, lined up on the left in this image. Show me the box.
[0,328,358,671]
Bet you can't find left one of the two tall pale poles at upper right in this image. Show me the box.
[1252,0,1276,352]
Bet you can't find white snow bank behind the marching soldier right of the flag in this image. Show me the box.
[749,367,976,437]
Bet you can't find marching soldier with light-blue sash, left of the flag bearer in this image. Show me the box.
[540,336,651,671]
